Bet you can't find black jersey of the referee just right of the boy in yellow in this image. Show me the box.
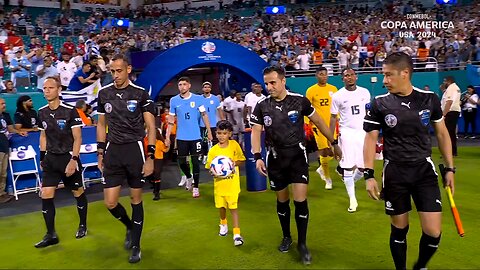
[250,92,315,148]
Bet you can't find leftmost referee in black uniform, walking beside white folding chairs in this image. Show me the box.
[35,77,88,248]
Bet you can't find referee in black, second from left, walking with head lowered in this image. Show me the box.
[97,55,156,263]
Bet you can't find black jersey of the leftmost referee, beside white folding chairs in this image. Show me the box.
[38,102,83,154]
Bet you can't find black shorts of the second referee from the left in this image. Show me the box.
[102,141,145,188]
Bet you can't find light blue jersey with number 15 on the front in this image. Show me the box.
[170,93,205,141]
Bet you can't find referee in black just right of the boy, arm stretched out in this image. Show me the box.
[250,66,341,264]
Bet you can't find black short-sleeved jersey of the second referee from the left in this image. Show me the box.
[97,82,155,144]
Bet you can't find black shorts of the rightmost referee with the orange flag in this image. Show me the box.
[382,158,442,215]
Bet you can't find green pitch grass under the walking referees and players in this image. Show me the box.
[0,147,480,269]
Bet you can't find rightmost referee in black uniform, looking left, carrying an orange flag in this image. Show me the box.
[364,52,455,269]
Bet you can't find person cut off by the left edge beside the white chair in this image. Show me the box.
[0,98,26,203]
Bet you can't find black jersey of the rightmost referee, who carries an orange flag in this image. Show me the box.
[363,88,443,162]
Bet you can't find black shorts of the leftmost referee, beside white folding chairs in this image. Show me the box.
[42,153,83,190]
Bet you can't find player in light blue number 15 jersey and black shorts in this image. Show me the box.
[165,77,213,198]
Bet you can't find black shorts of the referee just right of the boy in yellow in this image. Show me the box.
[266,144,309,191]
